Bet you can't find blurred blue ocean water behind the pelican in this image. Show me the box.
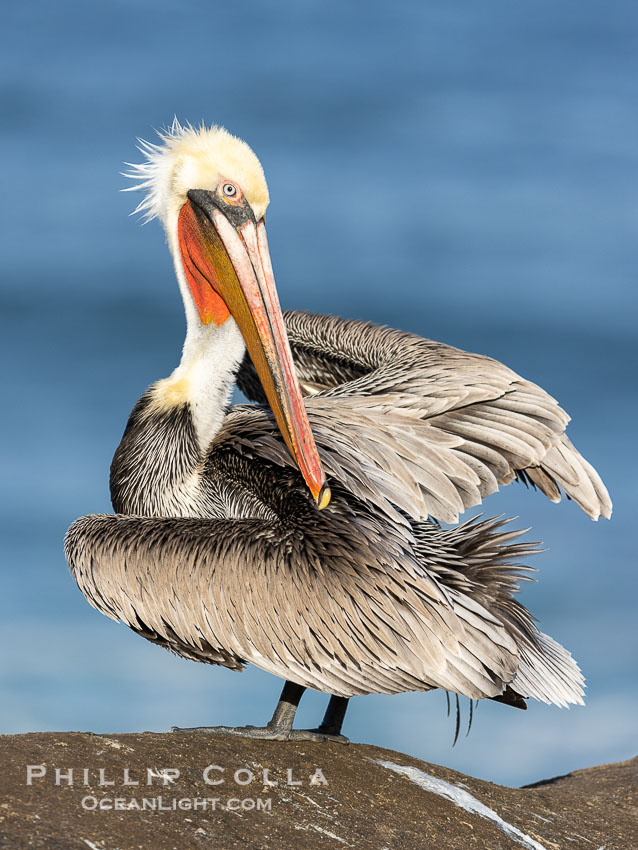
[0,0,638,784]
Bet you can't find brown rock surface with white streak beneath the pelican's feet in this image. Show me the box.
[0,732,638,850]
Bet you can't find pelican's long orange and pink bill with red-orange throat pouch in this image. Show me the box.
[178,189,330,509]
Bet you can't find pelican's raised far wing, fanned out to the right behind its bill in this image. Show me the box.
[238,312,611,522]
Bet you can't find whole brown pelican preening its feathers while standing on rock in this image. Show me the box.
[66,123,611,740]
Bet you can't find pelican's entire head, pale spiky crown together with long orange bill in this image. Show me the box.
[126,120,330,508]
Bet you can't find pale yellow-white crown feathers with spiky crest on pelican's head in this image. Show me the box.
[124,118,269,232]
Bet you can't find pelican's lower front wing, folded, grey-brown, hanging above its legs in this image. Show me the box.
[66,494,519,698]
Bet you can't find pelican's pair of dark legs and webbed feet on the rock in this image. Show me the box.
[170,682,350,744]
